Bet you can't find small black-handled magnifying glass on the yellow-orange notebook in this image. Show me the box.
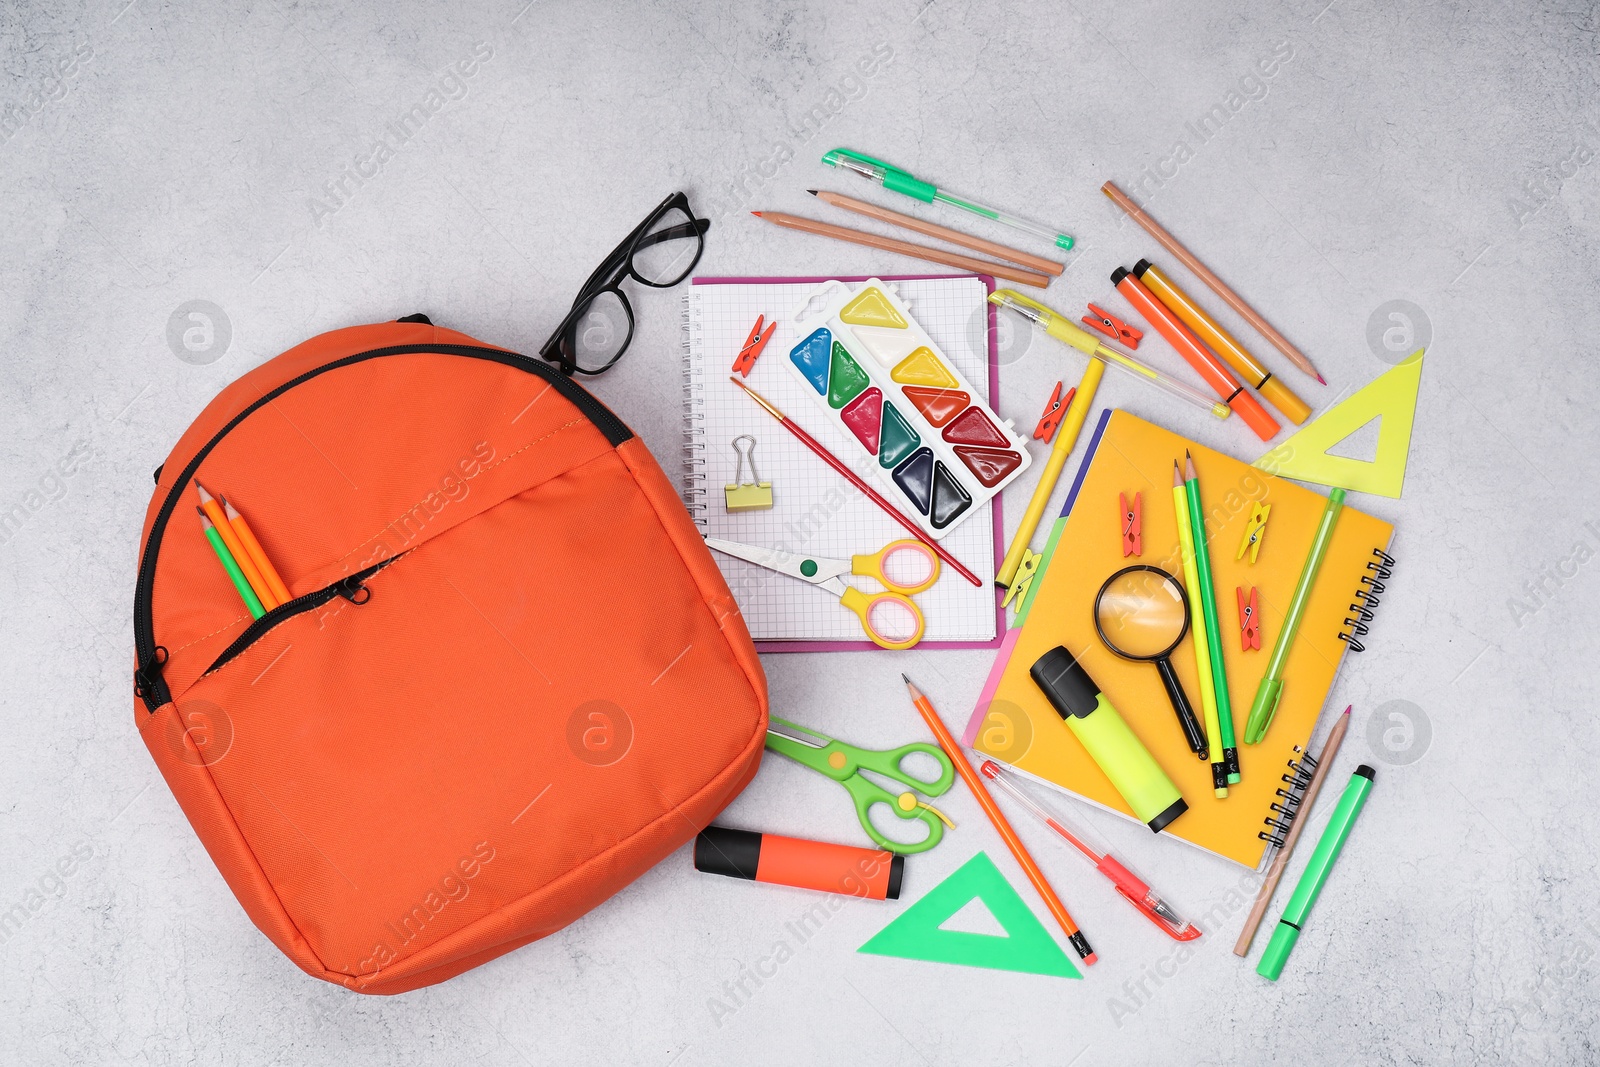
[1094,563,1208,760]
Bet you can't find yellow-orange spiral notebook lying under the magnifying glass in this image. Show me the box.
[963,411,1394,867]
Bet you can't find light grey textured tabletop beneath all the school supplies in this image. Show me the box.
[0,0,1600,1067]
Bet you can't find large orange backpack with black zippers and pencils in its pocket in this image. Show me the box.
[133,317,766,993]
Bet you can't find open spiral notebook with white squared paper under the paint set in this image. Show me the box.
[682,275,1005,651]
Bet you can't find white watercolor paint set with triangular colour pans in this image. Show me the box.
[787,278,1029,537]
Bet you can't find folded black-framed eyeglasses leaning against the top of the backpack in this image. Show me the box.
[539,192,710,374]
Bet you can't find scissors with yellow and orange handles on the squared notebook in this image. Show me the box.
[706,537,939,649]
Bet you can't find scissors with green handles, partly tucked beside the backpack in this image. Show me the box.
[766,717,955,854]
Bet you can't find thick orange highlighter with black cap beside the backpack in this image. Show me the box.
[694,825,906,901]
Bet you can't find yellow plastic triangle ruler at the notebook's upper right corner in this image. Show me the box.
[1254,349,1422,498]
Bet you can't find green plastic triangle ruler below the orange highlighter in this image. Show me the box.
[856,853,1083,977]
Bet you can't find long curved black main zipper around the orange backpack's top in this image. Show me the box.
[133,344,634,713]
